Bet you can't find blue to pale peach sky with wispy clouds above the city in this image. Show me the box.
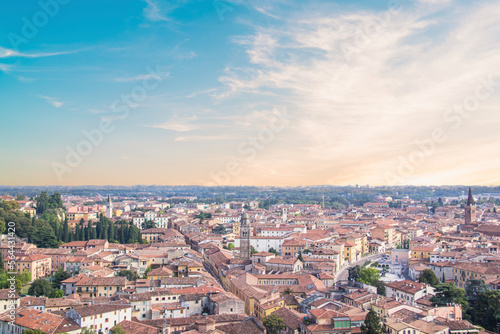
[0,0,500,186]
